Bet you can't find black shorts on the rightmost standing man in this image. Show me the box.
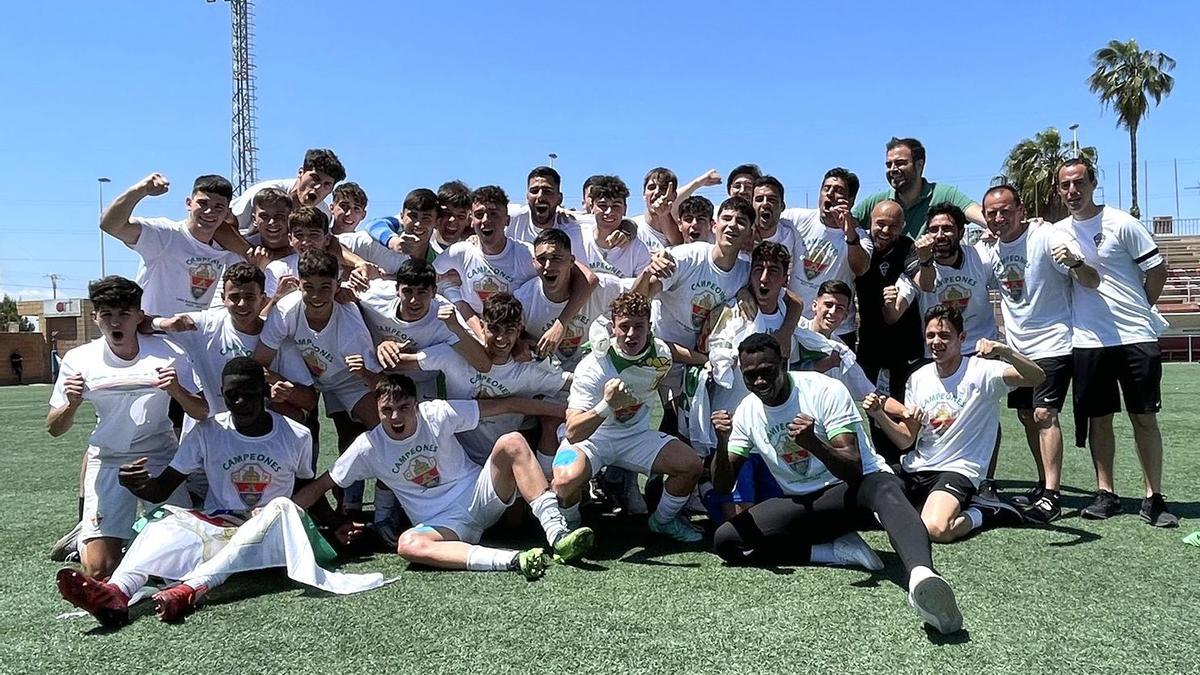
[1073,342,1163,418]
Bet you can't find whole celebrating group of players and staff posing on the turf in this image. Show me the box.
[47,138,1177,633]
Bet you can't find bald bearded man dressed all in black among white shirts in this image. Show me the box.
[854,199,935,462]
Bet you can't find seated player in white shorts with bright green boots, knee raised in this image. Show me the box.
[295,374,593,571]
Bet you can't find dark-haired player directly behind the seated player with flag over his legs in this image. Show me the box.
[151,261,317,420]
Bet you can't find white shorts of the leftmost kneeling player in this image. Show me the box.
[79,456,192,540]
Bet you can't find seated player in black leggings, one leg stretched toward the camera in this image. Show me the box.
[713,334,962,634]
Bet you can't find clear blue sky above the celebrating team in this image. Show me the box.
[0,0,1200,298]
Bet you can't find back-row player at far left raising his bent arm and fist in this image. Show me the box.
[100,173,250,316]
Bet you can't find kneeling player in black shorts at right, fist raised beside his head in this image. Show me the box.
[863,305,1045,543]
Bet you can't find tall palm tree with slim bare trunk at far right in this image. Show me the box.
[1087,40,1175,217]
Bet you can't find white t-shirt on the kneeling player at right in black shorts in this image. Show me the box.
[900,357,1010,486]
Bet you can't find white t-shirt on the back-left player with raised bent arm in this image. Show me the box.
[130,217,241,316]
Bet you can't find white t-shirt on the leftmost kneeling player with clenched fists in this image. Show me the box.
[50,335,200,464]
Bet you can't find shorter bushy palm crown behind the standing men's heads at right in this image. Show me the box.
[1004,126,1097,222]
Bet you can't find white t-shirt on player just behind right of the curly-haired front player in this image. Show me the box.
[654,241,750,350]
